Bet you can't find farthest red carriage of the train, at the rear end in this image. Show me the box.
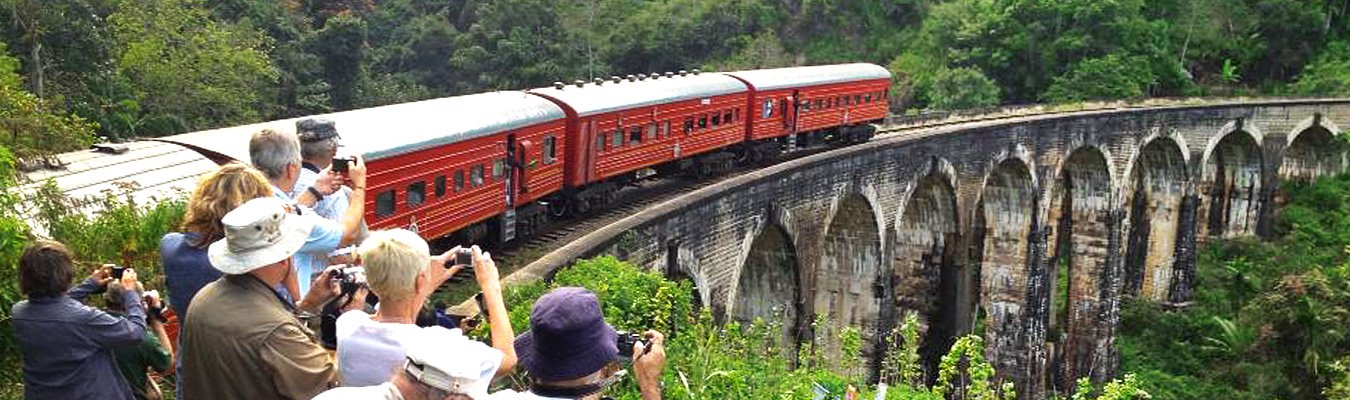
[725,64,891,155]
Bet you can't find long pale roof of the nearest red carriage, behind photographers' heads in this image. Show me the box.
[159,92,566,162]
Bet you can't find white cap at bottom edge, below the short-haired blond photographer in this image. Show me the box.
[404,326,504,400]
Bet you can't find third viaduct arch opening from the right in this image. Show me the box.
[1125,136,1188,301]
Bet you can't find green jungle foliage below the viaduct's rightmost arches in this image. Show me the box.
[1116,176,1350,399]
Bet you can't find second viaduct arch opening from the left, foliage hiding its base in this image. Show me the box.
[732,224,799,343]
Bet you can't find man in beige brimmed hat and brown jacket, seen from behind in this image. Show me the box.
[181,197,359,400]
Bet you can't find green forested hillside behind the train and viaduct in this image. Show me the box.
[0,0,1350,158]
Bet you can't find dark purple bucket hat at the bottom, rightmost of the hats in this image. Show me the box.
[516,288,618,381]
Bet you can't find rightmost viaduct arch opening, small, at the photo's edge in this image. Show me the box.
[1280,115,1346,181]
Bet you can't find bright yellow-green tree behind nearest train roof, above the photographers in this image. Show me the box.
[108,0,277,135]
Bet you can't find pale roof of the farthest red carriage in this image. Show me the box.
[725,62,891,91]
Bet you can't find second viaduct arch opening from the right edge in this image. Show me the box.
[1199,123,1265,236]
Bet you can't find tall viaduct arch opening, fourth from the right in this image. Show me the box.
[1045,146,1118,393]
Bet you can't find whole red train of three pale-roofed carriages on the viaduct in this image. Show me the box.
[157,64,891,242]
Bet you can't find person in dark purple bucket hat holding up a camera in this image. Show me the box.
[493,288,666,400]
